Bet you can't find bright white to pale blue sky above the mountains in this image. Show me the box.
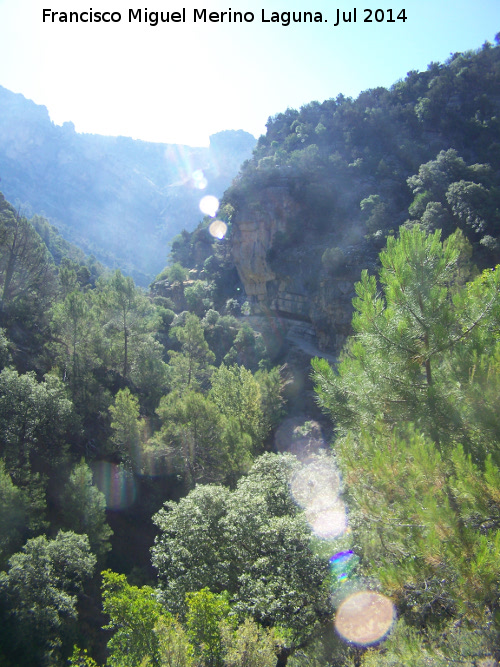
[0,0,500,146]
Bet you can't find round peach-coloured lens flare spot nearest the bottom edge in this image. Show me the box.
[335,591,396,646]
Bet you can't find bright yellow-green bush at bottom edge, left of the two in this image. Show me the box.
[102,570,162,667]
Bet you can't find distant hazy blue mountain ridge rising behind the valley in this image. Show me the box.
[0,86,256,285]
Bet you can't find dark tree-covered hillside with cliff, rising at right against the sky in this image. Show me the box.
[167,37,500,351]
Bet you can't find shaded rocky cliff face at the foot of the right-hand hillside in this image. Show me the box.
[232,186,374,354]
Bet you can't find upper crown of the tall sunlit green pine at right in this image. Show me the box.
[313,228,499,440]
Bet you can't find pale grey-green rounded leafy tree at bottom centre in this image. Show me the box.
[152,454,329,642]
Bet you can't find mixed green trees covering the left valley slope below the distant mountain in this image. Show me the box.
[0,190,292,665]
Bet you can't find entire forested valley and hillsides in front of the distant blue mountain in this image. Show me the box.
[0,36,500,667]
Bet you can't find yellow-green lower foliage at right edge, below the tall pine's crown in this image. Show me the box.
[337,425,500,626]
